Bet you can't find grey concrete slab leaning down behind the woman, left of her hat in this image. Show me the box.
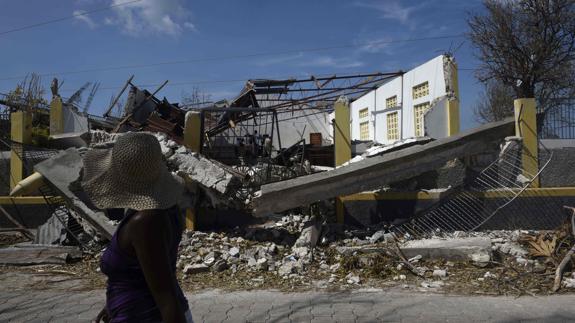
[34,148,116,239]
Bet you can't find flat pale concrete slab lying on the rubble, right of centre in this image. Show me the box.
[401,237,491,262]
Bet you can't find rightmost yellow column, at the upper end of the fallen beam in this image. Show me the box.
[514,98,539,187]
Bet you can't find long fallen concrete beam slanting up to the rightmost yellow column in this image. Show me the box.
[253,118,515,216]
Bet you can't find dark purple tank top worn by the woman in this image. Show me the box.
[100,207,189,322]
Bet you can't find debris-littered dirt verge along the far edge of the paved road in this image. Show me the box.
[0,248,573,296]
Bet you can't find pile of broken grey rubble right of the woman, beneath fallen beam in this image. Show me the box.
[171,223,575,295]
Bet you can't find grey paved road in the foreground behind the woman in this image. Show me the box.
[0,291,575,323]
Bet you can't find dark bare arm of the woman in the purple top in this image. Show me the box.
[130,210,186,323]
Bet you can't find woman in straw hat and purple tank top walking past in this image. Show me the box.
[82,133,192,322]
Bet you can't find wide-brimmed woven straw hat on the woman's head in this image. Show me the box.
[82,132,184,211]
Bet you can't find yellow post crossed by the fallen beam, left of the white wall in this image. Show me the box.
[333,96,351,224]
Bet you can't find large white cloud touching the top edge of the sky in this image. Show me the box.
[105,0,196,36]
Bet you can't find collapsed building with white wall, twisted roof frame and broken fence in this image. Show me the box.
[0,55,575,294]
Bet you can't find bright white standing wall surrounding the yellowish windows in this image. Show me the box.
[350,55,452,144]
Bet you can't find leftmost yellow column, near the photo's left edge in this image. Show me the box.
[10,111,32,190]
